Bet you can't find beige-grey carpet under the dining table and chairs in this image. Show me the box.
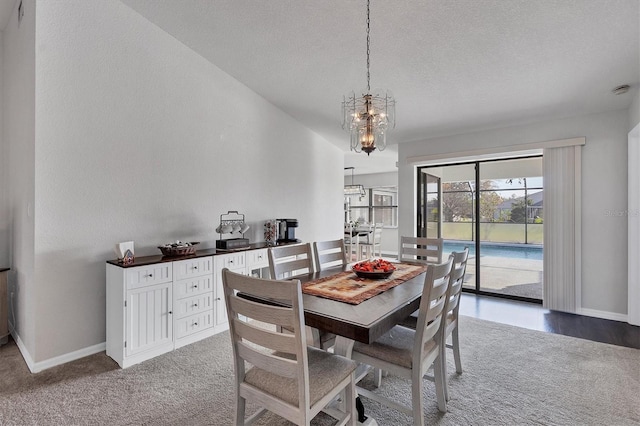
[0,317,640,426]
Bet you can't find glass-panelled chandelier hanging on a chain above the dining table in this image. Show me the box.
[342,0,396,155]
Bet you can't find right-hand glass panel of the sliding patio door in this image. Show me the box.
[477,157,543,299]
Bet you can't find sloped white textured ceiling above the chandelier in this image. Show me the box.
[122,0,640,174]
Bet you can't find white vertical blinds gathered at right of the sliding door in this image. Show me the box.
[543,145,582,312]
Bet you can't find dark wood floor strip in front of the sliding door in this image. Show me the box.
[460,293,640,349]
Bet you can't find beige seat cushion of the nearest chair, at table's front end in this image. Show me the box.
[244,347,357,407]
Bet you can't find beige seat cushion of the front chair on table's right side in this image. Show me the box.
[353,326,436,369]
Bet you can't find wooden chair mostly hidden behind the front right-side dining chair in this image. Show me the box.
[400,247,469,401]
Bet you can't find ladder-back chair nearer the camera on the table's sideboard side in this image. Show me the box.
[267,243,335,349]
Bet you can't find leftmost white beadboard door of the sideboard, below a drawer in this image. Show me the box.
[125,282,173,356]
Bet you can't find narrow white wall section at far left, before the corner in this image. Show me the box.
[0,0,38,360]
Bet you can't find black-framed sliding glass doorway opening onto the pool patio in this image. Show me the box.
[416,155,544,303]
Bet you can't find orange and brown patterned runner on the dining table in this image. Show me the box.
[302,263,427,305]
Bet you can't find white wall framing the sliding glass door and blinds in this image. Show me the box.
[398,110,628,317]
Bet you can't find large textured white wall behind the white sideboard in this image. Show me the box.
[20,0,343,363]
